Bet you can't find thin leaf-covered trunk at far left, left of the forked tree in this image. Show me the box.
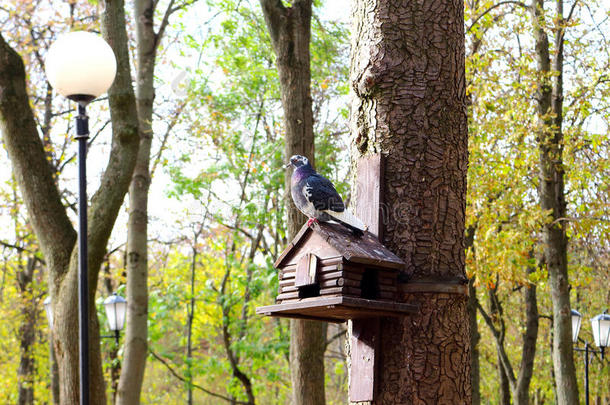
[17,258,38,405]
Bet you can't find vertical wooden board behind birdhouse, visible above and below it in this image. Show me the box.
[348,154,384,402]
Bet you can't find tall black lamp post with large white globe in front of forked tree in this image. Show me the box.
[45,31,116,405]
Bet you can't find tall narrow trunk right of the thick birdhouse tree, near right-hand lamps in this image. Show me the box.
[532,0,578,405]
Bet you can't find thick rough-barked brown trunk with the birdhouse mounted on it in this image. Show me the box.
[350,0,471,404]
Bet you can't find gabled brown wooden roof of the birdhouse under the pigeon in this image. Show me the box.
[274,222,405,270]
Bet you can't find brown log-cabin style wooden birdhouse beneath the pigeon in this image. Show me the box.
[256,223,415,322]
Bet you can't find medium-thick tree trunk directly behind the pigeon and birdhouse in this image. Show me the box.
[260,0,326,405]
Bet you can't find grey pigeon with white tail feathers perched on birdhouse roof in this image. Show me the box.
[285,155,366,236]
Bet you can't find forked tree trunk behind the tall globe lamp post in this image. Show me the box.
[0,1,138,405]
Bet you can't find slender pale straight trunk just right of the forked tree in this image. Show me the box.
[116,0,158,405]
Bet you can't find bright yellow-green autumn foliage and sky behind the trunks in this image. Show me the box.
[0,0,610,404]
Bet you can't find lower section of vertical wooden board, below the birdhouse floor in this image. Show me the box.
[349,318,380,402]
